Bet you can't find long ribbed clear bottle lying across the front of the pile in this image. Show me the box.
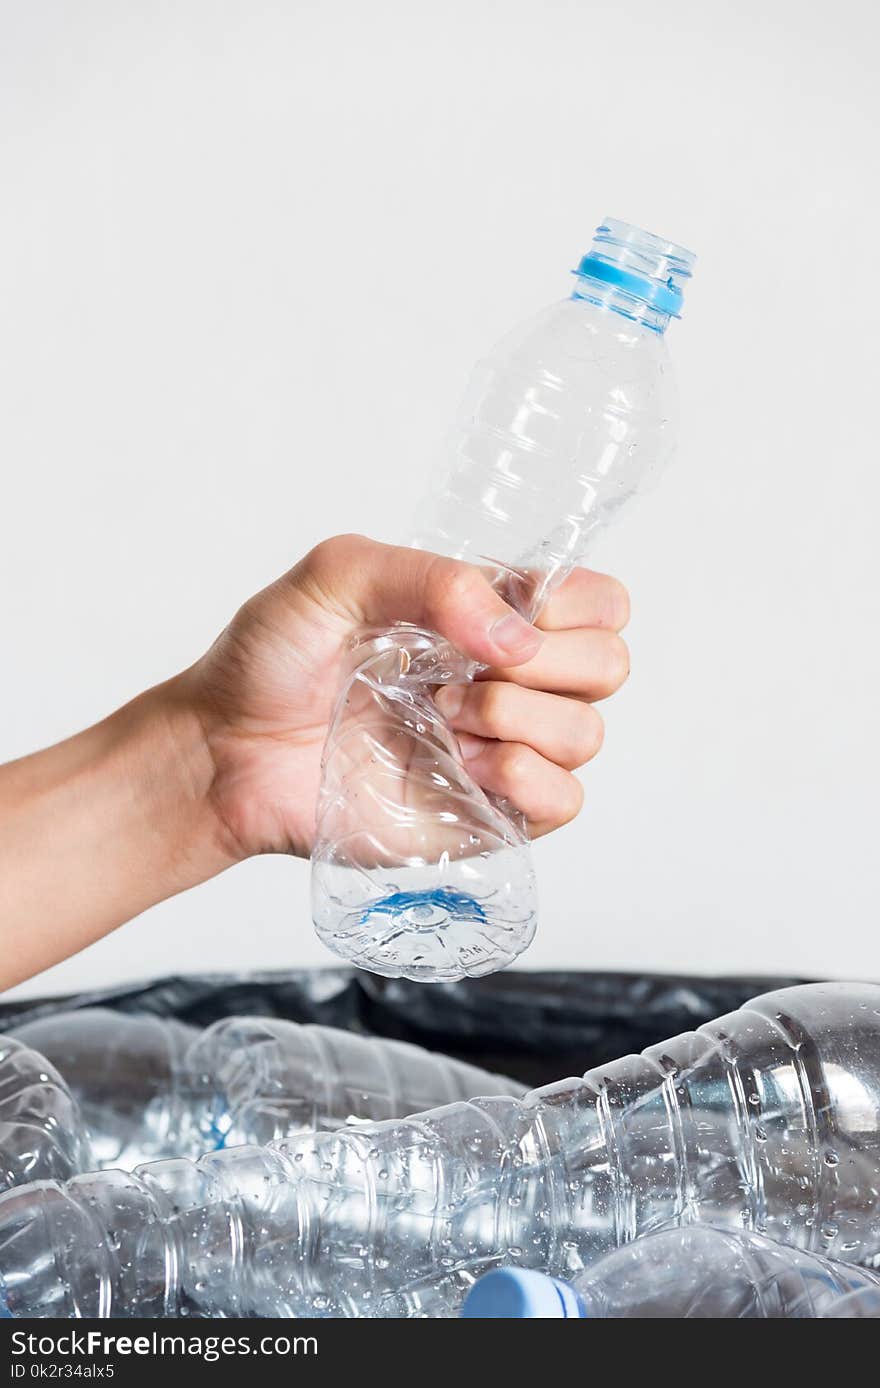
[0,983,880,1317]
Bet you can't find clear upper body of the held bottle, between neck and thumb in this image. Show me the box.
[414,298,677,602]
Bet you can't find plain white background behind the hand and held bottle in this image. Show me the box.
[0,0,880,992]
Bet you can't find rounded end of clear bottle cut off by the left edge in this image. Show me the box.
[0,1037,89,1191]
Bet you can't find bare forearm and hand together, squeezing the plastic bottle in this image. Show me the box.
[0,536,629,988]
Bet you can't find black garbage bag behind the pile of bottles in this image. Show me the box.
[0,969,806,1087]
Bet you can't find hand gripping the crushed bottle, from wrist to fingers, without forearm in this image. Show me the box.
[181,536,629,861]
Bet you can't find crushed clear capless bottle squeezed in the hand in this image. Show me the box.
[312,218,694,981]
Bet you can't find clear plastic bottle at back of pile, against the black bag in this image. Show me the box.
[17,1008,523,1160]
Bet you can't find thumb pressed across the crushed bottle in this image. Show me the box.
[293,534,544,666]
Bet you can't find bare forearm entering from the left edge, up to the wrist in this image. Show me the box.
[0,680,235,988]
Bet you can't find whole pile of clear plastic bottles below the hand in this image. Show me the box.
[0,983,880,1319]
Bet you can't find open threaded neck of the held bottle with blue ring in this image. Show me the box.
[575,217,697,318]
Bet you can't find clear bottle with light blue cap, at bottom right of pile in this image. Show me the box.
[461,1224,880,1320]
